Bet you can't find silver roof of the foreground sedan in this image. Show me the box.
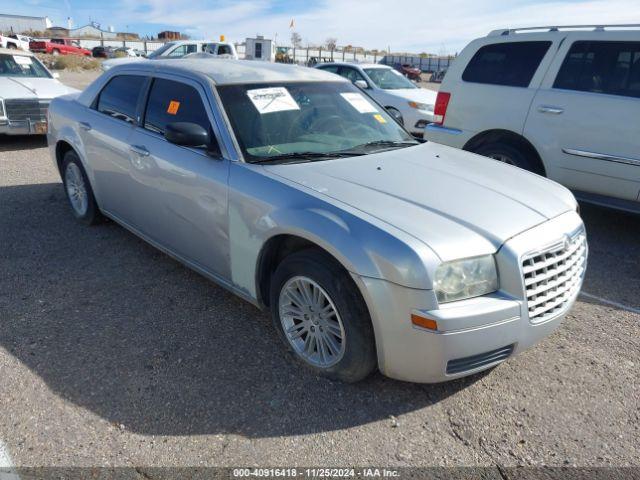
[122,57,348,85]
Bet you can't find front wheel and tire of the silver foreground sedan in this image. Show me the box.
[270,250,377,383]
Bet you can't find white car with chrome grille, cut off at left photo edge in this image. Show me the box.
[0,48,78,135]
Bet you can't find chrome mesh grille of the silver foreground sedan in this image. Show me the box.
[522,229,587,323]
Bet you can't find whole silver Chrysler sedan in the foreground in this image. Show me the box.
[49,59,587,382]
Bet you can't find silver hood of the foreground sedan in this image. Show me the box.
[265,143,576,261]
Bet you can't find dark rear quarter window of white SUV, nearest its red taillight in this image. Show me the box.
[462,42,551,87]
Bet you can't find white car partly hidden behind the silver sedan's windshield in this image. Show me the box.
[316,63,437,138]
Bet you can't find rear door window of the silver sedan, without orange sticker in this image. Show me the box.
[97,75,146,123]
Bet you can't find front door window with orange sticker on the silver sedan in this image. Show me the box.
[144,78,211,134]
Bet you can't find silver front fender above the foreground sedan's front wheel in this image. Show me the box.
[229,166,440,298]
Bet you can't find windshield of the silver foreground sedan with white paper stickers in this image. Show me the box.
[218,82,417,162]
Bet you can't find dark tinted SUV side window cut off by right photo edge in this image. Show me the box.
[553,42,640,98]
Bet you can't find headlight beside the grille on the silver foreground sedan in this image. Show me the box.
[433,255,498,303]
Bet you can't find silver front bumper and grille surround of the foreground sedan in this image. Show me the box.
[355,212,582,383]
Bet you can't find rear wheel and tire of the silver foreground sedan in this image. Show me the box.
[62,150,103,225]
